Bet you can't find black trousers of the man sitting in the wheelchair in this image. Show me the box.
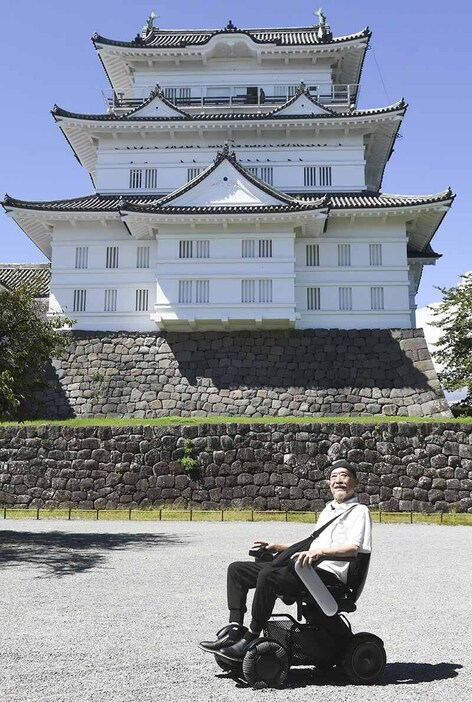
[227,561,339,633]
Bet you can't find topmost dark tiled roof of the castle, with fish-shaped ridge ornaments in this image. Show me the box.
[92,25,370,49]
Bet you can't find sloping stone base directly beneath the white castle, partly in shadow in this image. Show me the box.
[34,329,450,419]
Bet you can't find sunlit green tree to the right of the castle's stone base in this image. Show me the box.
[429,273,472,408]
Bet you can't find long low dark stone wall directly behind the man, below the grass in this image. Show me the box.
[0,422,472,512]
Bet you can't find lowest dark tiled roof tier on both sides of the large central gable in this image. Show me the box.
[3,190,454,212]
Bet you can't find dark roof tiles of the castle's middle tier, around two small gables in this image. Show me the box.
[52,98,407,122]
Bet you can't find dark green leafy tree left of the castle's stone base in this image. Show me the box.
[0,285,72,421]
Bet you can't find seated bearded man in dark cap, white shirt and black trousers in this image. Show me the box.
[200,459,372,661]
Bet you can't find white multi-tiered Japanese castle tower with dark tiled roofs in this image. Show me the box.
[3,18,453,332]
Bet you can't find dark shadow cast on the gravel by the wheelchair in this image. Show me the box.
[217,663,463,690]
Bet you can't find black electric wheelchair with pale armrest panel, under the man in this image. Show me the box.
[215,549,386,689]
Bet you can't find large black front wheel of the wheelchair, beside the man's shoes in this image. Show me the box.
[243,639,290,690]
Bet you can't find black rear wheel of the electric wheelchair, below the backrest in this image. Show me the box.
[344,634,387,685]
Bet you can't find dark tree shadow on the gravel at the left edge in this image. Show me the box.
[0,531,184,578]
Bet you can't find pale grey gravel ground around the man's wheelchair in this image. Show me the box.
[0,521,472,702]
